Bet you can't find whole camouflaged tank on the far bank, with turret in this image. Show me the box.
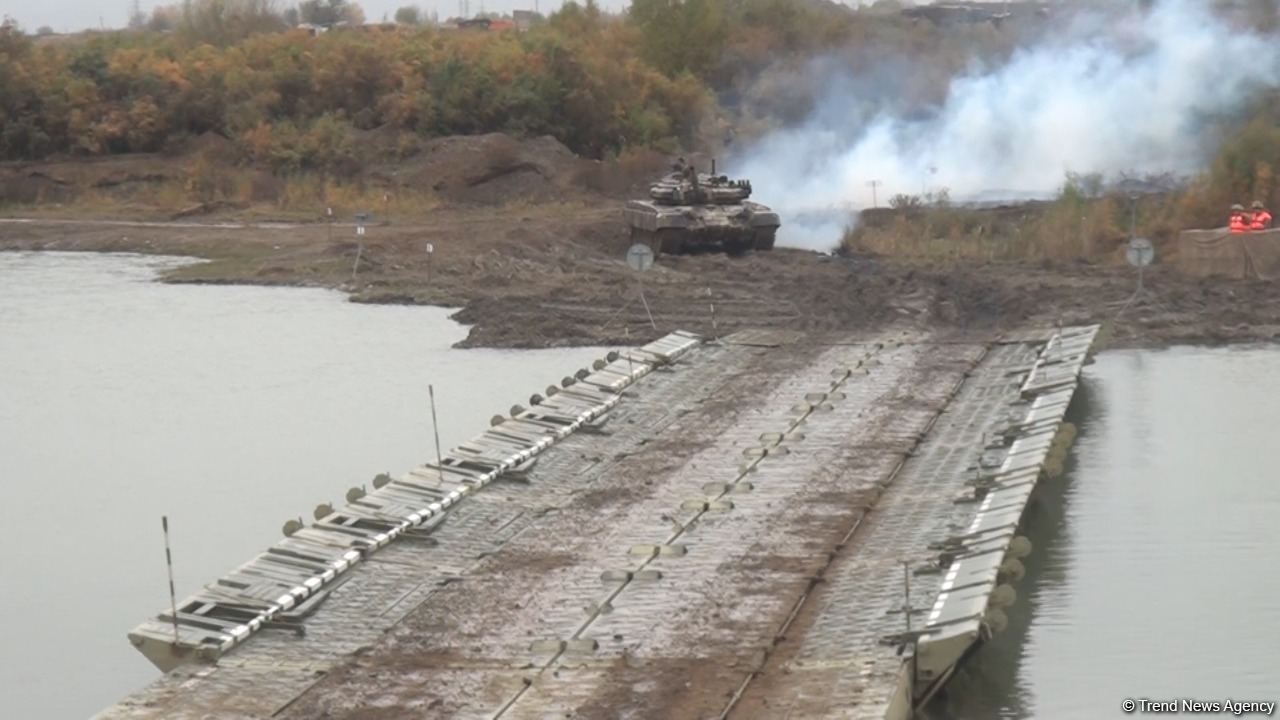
[623,161,782,255]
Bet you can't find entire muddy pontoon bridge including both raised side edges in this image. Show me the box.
[101,327,1097,719]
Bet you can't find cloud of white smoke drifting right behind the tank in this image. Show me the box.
[735,0,1280,249]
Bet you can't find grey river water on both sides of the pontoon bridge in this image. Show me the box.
[0,254,1280,720]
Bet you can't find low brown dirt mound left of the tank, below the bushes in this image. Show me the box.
[394,133,582,205]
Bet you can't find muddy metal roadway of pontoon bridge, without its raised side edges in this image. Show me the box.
[102,326,1092,719]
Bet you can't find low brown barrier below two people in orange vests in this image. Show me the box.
[1176,229,1280,281]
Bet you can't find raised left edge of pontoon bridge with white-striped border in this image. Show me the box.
[129,332,699,671]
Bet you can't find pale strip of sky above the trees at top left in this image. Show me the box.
[0,0,630,32]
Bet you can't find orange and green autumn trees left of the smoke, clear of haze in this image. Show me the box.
[0,0,860,163]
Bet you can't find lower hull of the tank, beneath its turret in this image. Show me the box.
[623,200,782,255]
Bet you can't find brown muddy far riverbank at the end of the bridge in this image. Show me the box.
[0,197,1280,347]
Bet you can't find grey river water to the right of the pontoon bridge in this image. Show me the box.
[929,347,1280,720]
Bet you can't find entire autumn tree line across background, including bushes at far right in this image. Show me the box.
[0,0,1280,211]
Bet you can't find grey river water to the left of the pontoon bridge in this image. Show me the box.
[0,252,603,719]
